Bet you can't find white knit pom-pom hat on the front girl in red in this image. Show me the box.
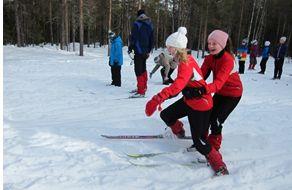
[165,26,188,48]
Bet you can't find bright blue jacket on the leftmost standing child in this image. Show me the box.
[110,36,123,66]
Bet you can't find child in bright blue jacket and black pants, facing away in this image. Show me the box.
[109,31,123,87]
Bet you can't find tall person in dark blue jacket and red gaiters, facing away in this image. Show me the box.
[128,10,154,98]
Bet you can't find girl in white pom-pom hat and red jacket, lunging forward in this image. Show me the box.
[145,27,228,175]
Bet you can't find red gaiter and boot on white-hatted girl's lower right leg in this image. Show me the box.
[206,147,229,176]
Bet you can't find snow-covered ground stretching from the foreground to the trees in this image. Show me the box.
[3,46,292,190]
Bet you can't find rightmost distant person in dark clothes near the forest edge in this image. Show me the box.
[273,36,287,80]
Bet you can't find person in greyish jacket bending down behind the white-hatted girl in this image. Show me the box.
[150,52,177,85]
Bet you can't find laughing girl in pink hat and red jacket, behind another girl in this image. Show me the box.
[201,30,242,150]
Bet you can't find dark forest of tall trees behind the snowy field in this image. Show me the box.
[3,0,292,56]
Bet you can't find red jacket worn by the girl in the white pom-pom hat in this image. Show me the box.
[159,55,213,111]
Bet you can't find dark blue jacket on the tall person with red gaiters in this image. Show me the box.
[129,15,154,55]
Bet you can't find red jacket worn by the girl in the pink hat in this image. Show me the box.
[201,52,243,97]
